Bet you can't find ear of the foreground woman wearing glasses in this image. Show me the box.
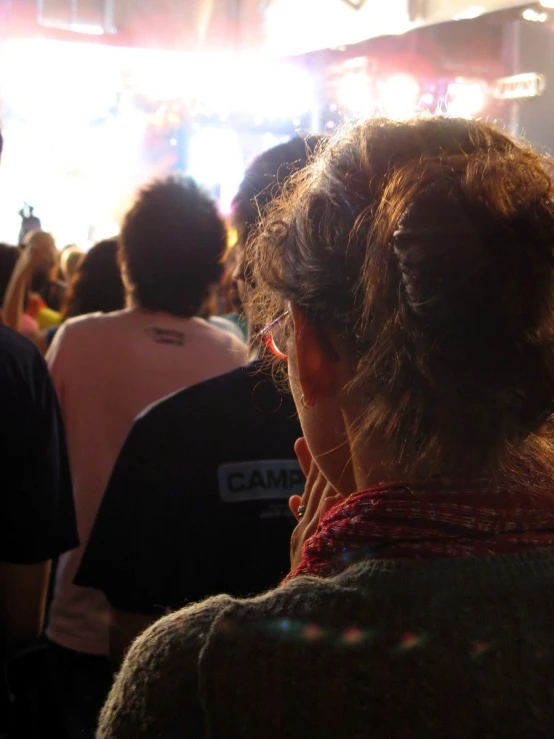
[291,305,338,407]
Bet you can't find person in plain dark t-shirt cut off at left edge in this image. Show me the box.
[0,326,79,733]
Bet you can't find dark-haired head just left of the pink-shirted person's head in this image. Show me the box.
[63,239,125,318]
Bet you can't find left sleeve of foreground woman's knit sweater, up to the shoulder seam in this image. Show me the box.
[96,595,234,739]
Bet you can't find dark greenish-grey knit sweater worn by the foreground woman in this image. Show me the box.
[97,550,554,739]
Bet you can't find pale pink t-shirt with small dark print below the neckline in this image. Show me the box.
[47,309,245,654]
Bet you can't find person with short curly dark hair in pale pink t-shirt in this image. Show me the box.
[46,179,246,736]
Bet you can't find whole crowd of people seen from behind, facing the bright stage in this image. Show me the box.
[0,117,554,739]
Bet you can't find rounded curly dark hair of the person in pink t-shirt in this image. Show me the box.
[120,177,227,317]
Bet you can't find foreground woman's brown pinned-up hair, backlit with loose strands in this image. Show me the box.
[247,118,554,480]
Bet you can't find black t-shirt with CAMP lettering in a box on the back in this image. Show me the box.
[75,363,304,614]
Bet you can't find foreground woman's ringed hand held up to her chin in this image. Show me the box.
[289,436,342,570]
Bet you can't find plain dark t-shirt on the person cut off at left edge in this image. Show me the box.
[0,326,79,564]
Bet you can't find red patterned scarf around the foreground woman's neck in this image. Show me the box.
[285,480,554,582]
